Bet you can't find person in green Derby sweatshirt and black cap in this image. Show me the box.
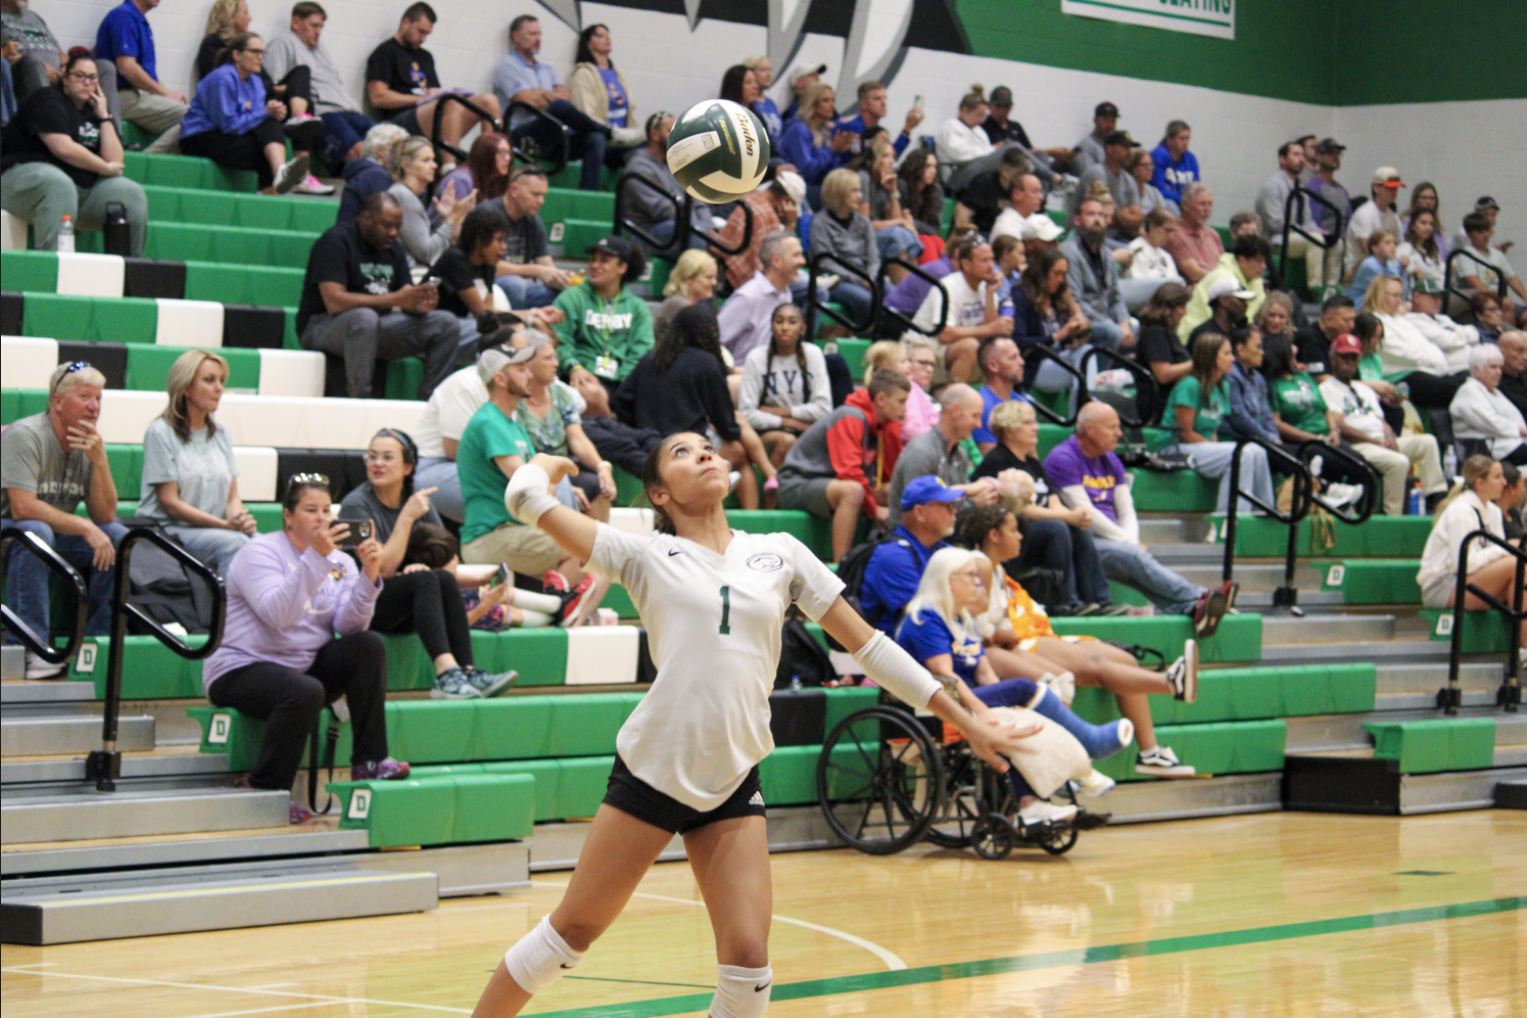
[554,235,654,389]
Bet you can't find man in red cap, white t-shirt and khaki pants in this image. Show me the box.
[1321,334,1448,516]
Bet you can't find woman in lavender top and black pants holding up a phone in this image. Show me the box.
[202,473,408,824]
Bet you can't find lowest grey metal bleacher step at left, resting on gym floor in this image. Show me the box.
[0,854,440,945]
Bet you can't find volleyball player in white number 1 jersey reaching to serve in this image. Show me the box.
[473,432,1034,1018]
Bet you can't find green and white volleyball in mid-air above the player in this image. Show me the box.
[669,99,770,205]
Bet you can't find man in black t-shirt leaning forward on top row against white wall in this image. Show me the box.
[366,3,499,162]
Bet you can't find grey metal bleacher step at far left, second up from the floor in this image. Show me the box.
[0,774,290,844]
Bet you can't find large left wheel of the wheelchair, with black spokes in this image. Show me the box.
[817,707,944,855]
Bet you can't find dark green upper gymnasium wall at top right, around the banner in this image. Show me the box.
[950,0,1527,105]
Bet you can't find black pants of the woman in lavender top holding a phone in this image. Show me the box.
[206,630,386,791]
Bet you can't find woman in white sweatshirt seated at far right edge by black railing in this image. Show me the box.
[1416,456,1527,637]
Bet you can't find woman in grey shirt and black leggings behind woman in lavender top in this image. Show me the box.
[339,427,518,699]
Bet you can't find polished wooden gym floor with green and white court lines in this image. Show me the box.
[0,810,1527,1018]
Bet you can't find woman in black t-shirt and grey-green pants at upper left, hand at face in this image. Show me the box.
[0,49,148,258]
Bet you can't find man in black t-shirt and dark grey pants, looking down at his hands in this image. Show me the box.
[296,191,461,400]
